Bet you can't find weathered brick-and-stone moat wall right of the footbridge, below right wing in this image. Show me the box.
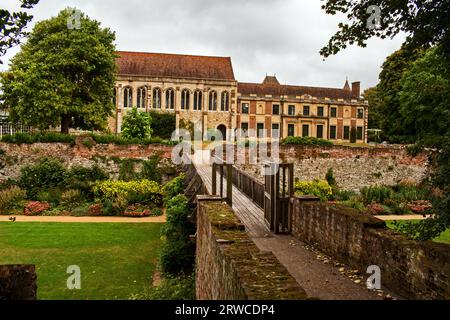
[236,146,428,191]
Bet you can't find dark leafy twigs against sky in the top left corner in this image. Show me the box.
[0,0,39,64]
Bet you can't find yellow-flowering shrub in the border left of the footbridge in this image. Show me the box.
[93,179,163,205]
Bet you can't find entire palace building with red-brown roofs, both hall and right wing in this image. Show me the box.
[109,51,368,142]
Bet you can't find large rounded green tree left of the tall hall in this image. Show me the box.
[0,8,116,133]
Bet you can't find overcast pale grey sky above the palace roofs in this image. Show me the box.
[0,0,404,88]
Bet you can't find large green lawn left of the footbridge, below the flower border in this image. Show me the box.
[0,222,162,300]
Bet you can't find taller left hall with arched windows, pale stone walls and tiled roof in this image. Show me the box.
[110,52,237,135]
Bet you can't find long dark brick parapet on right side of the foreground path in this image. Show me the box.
[292,198,450,299]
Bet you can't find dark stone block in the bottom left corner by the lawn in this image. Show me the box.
[0,265,37,301]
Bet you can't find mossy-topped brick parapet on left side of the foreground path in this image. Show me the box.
[196,197,307,300]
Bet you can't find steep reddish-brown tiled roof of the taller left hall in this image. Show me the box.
[117,51,235,80]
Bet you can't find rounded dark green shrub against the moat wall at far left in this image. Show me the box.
[19,158,66,199]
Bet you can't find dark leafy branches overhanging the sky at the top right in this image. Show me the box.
[320,0,450,58]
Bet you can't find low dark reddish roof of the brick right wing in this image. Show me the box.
[238,81,358,100]
